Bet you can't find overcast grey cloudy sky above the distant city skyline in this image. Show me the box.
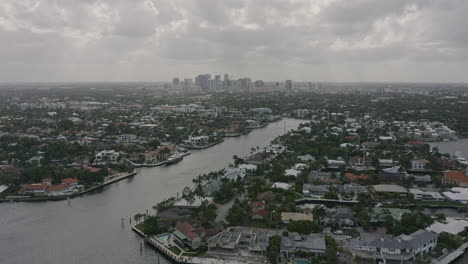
[0,0,468,82]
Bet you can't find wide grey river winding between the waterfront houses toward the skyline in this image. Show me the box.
[0,119,303,263]
